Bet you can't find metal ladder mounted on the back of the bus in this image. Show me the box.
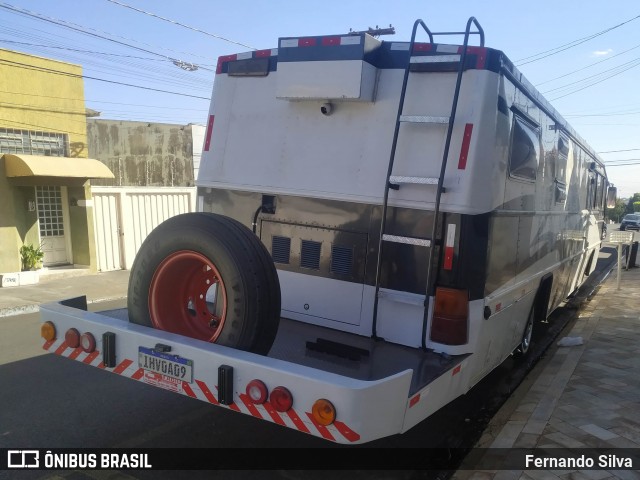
[372,17,484,349]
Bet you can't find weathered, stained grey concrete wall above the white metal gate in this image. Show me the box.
[87,118,195,187]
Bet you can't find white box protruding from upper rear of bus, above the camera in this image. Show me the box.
[276,33,382,102]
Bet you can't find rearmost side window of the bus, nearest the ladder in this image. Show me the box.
[509,116,540,180]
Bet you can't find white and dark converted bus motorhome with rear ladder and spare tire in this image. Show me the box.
[42,18,608,444]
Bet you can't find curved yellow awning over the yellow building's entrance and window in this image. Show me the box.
[3,153,115,178]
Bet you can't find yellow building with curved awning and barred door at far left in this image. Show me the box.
[0,49,114,280]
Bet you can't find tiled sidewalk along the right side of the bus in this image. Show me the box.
[453,267,640,480]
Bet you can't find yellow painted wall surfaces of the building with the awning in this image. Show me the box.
[0,49,96,273]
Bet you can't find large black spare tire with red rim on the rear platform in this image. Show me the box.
[127,213,281,355]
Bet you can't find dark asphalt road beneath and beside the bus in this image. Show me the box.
[0,248,611,480]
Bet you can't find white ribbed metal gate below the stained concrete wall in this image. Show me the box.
[91,186,196,271]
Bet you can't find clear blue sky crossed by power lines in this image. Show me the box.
[0,0,640,198]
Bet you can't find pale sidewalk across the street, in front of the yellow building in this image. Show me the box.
[0,269,129,318]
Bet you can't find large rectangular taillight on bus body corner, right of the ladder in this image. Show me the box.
[431,287,469,345]
